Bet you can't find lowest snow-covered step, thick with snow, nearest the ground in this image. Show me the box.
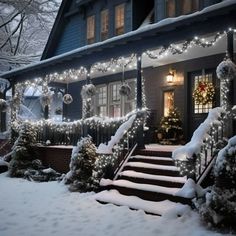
[95,190,189,216]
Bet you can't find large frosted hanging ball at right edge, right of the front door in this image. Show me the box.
[216,55,236,80]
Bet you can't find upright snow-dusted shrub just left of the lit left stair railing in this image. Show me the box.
[64,136,97,192]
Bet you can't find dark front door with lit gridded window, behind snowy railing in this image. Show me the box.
[187,69,220,140]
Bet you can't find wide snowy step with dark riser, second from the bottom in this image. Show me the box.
[100,179,191,204]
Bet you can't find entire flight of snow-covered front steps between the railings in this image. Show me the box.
[98,150,192,215]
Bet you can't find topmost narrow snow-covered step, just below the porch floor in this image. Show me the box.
[129,155,174,165]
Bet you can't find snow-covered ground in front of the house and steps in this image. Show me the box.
[0,173,230,236]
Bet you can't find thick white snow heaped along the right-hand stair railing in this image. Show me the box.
[172,107,225,160]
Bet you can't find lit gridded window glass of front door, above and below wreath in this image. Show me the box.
[193,73,213,114]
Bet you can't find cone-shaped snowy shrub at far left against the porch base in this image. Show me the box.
[9,123,60,181]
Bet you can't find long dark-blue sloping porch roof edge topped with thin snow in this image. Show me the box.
[1,0,236,79]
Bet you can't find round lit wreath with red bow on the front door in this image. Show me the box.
[193,81,215,105]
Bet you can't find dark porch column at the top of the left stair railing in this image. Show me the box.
[136,54,145,149]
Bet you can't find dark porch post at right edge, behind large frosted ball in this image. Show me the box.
[227,31,236,134]
